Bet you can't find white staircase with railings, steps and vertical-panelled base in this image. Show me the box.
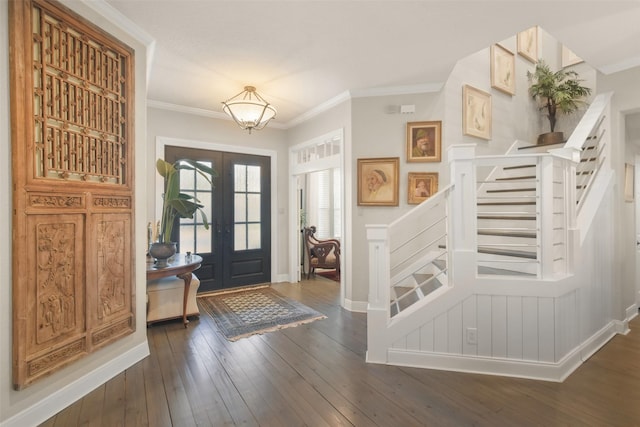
[367,94,613,381]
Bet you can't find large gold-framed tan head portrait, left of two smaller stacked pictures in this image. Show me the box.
[358,157,400,206]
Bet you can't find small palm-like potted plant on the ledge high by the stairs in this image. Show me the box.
[527,60,591,145]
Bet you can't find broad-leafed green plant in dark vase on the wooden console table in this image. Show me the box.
[149,159,217,268]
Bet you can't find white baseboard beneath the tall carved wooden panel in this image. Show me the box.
[0,341,149,427]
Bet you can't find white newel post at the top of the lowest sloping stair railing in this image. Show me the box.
[447,144,478,286]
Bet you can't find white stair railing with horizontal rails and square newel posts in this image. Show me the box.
[366,94,611,363]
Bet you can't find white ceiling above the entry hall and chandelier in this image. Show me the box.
[106,0,640,127]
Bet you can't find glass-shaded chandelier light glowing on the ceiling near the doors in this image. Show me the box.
[222,86,276,133]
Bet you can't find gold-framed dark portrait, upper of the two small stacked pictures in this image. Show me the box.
[407,121,442,162]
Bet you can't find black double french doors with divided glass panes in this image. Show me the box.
[165,146,271,292]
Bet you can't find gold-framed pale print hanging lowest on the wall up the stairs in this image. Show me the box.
[462,85,491,139]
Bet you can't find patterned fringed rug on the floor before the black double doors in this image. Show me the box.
[198,287,327,341]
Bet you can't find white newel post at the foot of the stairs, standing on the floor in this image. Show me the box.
[365,224,391,363]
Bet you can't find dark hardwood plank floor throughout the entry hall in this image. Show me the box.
[42,277,640,427]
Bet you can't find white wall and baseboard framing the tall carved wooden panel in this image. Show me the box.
[0,0,149,426]
